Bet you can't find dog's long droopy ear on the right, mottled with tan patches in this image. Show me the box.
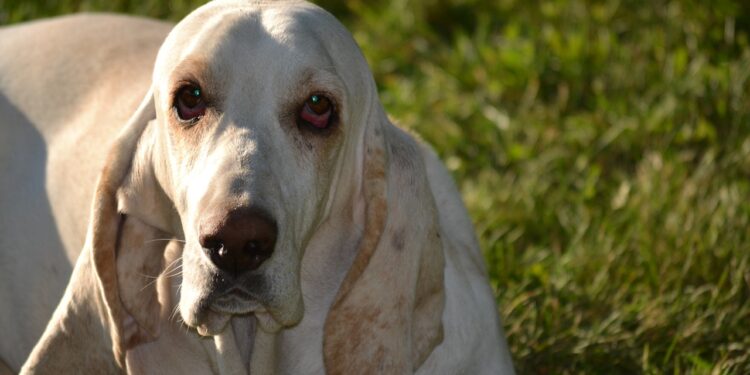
[323,118,445,374]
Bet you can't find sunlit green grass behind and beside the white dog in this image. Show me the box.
[0,0,750,374]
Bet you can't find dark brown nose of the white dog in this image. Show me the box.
[199,208,277,276]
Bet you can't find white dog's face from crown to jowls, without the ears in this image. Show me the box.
[143,2,369,334]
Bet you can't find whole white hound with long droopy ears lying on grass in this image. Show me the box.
[0,1,513,375]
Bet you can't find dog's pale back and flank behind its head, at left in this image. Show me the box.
[0,15,171,371]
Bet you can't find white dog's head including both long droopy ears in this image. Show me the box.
[89,1,443,372]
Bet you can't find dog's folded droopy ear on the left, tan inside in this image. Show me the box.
[87,91,169,369]
